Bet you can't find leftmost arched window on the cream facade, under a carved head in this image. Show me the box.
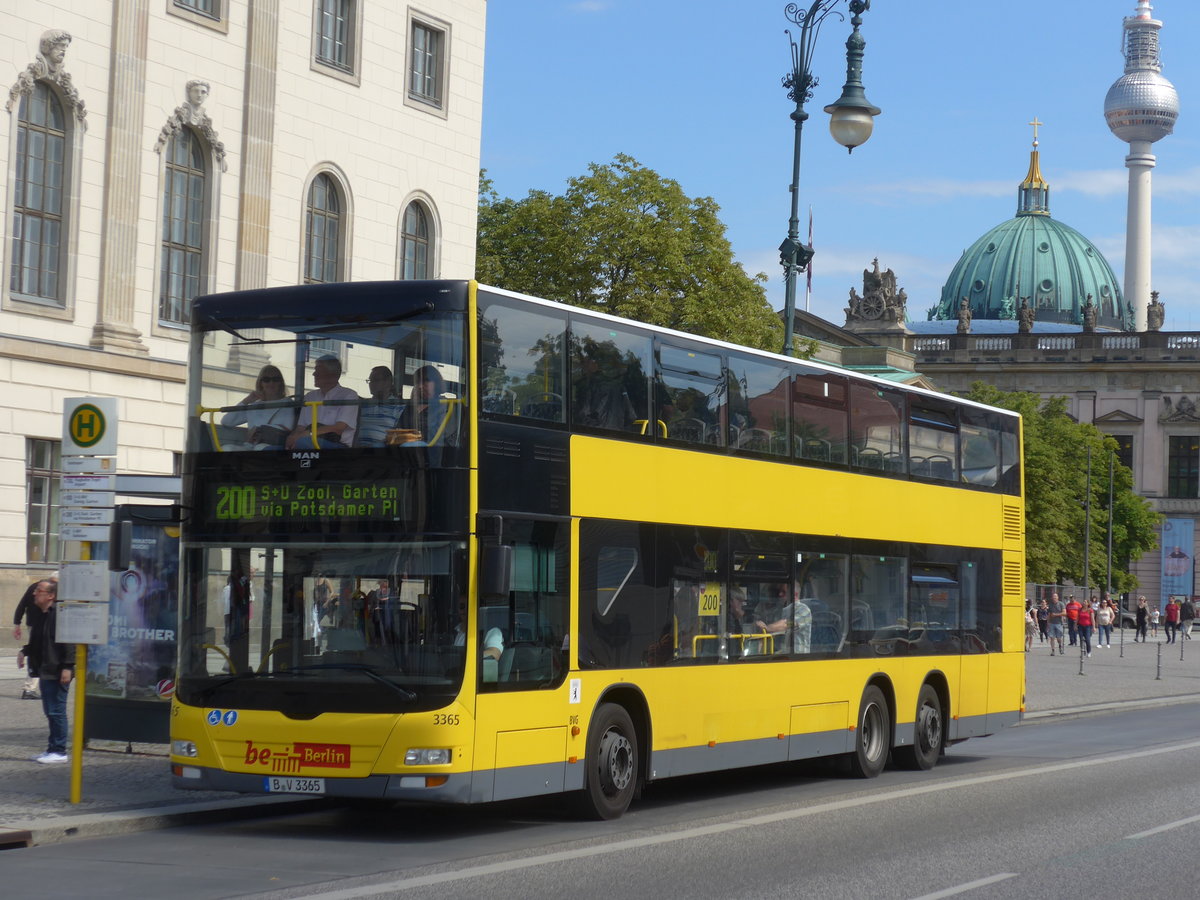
[8,82,67,305]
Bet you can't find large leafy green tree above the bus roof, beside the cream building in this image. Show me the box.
[475,155,792,350]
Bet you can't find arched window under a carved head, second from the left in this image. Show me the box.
[158,127,208,325]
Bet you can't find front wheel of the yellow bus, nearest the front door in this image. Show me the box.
[580,688,649,820]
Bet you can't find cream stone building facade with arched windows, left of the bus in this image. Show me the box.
[0,0,486,617]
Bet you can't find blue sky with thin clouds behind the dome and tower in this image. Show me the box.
[481,0,1200,330]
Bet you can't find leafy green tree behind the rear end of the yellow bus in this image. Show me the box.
[967,382,1162,590]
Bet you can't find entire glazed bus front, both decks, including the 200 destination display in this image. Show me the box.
[178,282,469,719]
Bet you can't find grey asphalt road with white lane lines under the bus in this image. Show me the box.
[0,703,1200,900]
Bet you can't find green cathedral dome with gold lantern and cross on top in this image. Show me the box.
[931,140,1134,331]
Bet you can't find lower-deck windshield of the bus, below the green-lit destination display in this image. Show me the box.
[178,540,466,719]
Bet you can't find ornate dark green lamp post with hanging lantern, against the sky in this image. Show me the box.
[779,0,880,356]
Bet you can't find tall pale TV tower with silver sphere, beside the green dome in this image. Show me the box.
[1104,0,1180,331]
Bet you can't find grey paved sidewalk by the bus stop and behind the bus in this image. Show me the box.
[0,632,1200,848]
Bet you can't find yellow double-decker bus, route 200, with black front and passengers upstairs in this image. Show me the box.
[172,281,1024,817]
